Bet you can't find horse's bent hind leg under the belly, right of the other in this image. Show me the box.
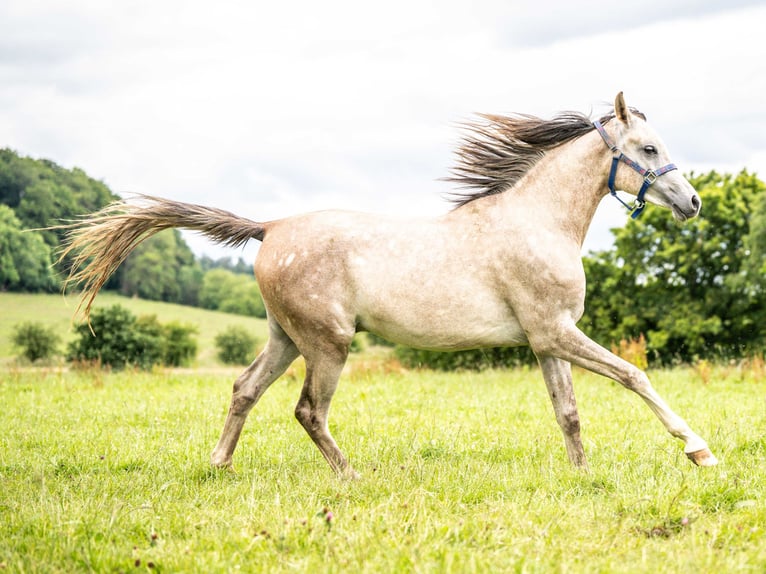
[295,349,359,478]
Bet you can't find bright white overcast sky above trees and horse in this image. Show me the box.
[0,0,766,257]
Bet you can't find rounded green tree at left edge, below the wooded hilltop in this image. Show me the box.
[0,204,58,291]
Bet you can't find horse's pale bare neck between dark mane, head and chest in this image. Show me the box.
[502,131,611,246]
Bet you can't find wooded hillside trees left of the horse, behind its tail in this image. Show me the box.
[0,149,266,317]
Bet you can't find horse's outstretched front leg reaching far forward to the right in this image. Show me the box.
[530,323,718,466]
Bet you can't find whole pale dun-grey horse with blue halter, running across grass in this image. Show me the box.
[61,92,718,477]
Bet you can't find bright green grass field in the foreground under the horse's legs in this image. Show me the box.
[0,362,766,573]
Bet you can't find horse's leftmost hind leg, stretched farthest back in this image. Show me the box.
[216,320,300,467]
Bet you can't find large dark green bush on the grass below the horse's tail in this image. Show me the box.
[67,305,196,369]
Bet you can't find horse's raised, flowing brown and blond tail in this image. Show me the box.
[57,195,264,320]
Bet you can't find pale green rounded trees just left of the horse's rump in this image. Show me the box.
[199,268,266,318]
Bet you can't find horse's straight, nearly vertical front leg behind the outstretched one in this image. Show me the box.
[538,356,588,470]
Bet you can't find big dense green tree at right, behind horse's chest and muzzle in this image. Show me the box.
[581,171,766,363]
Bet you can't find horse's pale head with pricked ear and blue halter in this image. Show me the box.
[597,92,702,221]
